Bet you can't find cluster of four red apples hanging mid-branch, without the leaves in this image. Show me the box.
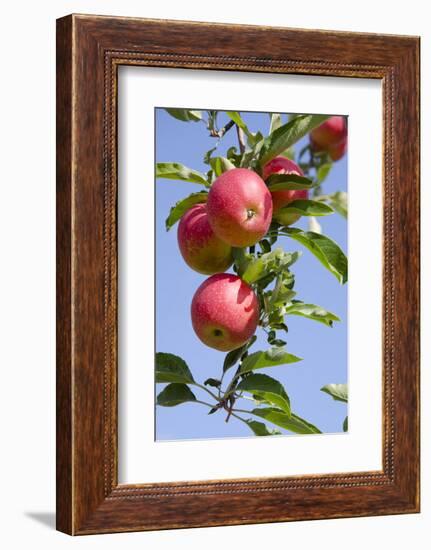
[178,157,308,351]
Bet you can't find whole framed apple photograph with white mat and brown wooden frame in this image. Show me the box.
[57,15,419,535]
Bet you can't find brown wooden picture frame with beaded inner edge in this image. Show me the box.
[57,15,419,535]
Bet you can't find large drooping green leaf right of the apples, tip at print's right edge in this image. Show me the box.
[279,227,347,284]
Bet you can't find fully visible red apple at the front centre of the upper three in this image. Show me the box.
[207,168,272,248]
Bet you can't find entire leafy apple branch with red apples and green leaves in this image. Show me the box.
[155,109,347,436]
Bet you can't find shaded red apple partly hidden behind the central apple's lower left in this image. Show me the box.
[177,204,233,275]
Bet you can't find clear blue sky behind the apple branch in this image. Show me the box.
[156,109,348,440]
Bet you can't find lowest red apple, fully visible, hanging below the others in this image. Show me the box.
[191,273,259,351]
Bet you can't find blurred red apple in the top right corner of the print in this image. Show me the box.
[310,116,347,160]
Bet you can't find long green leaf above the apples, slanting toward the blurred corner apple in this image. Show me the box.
[260,115,329,166]
